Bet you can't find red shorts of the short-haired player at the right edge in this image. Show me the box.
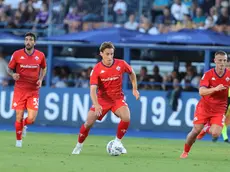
[193,114,225,127]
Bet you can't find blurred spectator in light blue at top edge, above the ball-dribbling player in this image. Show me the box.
[113,0,127,24]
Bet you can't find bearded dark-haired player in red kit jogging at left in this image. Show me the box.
[8,32,46,147]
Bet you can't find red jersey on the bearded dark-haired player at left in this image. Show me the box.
[8,49,46,90]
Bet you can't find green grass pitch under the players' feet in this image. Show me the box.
[0,131,230,172]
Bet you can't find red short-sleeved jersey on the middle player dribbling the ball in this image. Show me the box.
[90,59,132,100]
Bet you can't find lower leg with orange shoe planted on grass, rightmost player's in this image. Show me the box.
[180,124,204,158]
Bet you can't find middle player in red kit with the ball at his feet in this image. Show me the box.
[72,42,139,154]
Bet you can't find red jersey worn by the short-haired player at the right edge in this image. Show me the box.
[197,68,230,114]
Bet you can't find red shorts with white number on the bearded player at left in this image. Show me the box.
[12,88,39,110]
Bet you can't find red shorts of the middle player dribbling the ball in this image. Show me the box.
[90,99,128,121]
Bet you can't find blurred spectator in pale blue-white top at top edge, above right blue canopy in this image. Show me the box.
[171,0,189,21]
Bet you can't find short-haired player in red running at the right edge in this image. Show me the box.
[180,51,230,158]
